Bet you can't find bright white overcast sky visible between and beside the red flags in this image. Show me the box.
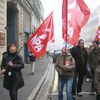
[41,0,100,49]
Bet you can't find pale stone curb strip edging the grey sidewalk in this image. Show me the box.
[27,63,50,100]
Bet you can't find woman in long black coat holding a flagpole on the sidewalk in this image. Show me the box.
[1,44,24,100]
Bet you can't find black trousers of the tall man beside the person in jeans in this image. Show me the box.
[72,69,84,95]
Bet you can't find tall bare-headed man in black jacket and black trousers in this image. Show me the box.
[70,39,87,96]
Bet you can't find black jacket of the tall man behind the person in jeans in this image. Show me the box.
[70,46,88,70]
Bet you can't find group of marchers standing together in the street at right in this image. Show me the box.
[55,39,100,100]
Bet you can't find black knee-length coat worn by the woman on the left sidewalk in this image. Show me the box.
[1,52,24,90]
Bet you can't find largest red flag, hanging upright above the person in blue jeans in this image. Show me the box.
[62,0,90,45]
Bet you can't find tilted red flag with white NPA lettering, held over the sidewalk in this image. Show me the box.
[27,12,54,58]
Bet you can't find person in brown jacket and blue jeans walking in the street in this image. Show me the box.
[55,47,75,100]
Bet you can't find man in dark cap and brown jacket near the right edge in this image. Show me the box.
[88,40,100,95]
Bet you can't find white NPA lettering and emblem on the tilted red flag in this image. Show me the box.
[31,34,47,52]
